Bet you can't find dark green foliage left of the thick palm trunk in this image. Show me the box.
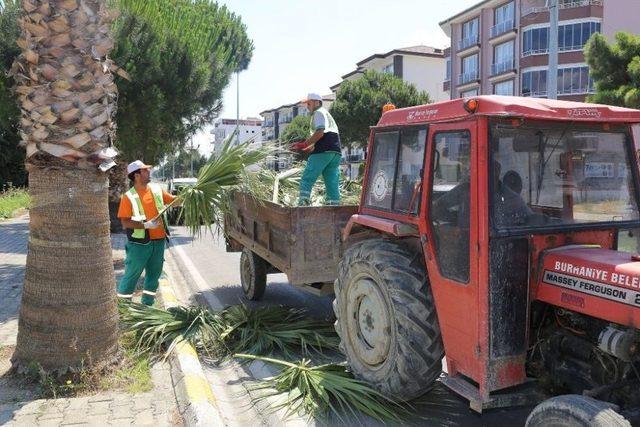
[0,1,27,187]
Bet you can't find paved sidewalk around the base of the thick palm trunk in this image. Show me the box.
[0,217,182,427]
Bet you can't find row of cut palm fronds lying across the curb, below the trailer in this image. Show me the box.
[120,302,339,359]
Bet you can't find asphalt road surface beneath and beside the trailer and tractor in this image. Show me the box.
[169,227,532,427]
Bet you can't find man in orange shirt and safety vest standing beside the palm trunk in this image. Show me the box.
[118,160,178,305]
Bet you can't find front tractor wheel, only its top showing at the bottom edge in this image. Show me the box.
[526,394,631,427]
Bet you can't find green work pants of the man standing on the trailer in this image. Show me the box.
[298,151,342,206]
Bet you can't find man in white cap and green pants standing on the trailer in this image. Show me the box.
[298,93,342,206]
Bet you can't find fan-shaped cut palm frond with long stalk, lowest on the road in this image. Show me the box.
[235,353,409,424]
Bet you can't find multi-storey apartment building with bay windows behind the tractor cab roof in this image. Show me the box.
[440,0,640,101]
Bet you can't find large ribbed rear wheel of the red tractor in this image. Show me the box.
[333,239,444,400]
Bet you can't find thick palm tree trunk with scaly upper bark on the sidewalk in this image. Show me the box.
[12,0,118,370]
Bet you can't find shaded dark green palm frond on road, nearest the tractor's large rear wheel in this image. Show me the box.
[220,305,340,357]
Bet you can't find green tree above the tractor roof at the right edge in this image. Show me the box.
[584,32,640,108]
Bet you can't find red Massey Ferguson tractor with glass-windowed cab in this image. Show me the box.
[336,96,640,422]
